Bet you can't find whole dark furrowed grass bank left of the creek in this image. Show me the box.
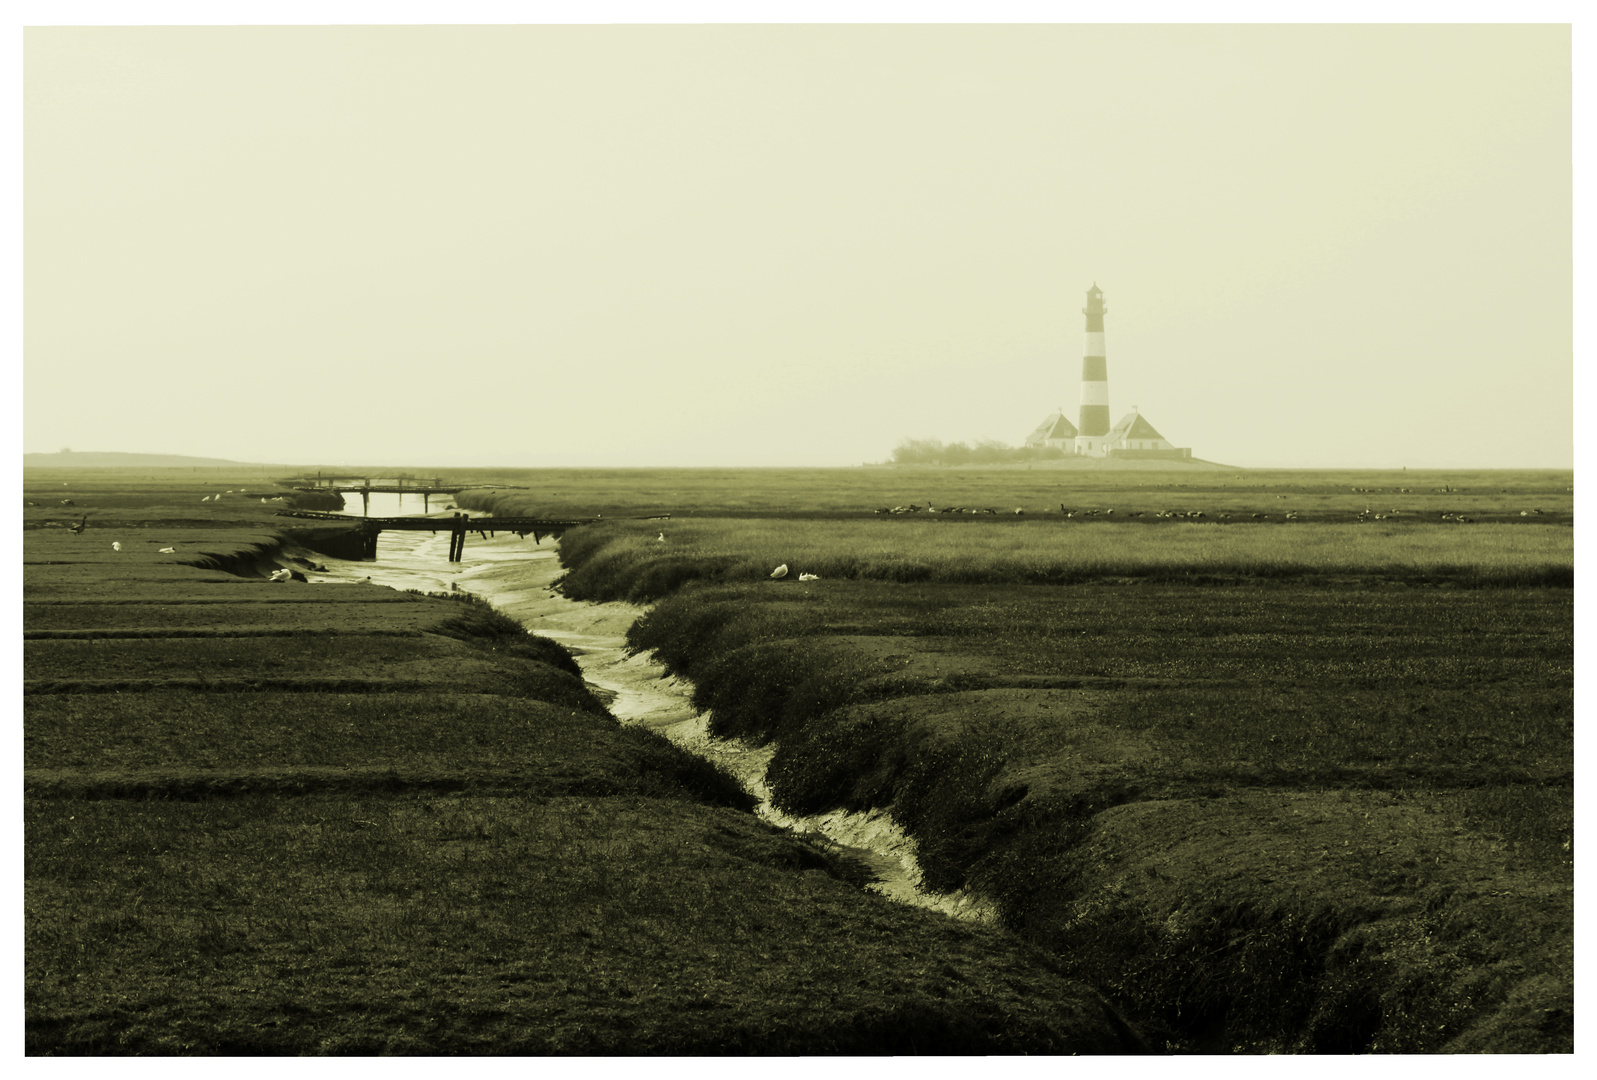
[22,479,1140,1054]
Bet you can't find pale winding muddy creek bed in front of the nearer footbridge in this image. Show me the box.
[310,532,993,920]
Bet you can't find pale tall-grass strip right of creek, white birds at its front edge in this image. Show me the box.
[533,514,1575,602]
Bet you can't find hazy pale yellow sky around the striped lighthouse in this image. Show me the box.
[22,15,1573,468]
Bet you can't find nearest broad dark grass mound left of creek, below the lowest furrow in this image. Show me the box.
[24,792,1140,1054]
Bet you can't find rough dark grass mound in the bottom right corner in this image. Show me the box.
[977,792,1573,1053]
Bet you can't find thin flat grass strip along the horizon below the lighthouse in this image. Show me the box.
[22,462,1575,524]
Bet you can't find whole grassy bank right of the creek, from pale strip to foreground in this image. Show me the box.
[562,521,1573,1051]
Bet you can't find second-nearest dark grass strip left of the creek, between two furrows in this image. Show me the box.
[22,690,754,808]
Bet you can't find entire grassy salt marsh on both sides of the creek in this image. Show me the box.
[22,463,1575,1053]
